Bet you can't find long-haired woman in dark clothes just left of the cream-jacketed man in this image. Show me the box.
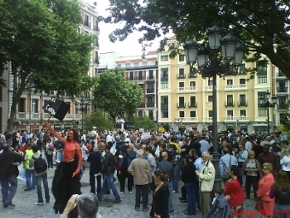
[181,155,197,216]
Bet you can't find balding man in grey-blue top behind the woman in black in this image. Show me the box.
[157,151,174,213]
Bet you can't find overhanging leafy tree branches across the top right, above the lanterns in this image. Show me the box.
[105,0,290,79]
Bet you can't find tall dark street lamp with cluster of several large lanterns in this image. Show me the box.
[184,26,245,188]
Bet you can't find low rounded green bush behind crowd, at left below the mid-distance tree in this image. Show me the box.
[84,109,114,131]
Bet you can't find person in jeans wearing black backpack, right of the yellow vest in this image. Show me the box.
[30,146,50,205]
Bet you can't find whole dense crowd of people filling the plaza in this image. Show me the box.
[0,126,290,218]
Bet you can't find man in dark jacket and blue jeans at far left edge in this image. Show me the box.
[0,144,22,207]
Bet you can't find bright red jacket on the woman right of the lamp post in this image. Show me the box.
[224,179,245,207]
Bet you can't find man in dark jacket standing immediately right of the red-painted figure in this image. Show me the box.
[87,143,104,194]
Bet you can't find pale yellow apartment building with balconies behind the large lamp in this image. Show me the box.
[158,39,273,132]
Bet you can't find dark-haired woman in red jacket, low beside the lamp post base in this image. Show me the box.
[224,165,245,210]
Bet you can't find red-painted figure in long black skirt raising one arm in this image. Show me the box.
[44,122,83,218]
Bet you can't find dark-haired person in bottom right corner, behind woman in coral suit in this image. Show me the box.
[269,170,290,218]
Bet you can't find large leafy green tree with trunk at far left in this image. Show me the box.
[0,0,94,129]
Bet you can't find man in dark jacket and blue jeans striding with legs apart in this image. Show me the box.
[97,145,121,203]
